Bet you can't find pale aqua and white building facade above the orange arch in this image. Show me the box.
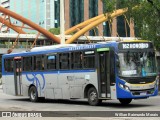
[10,0,54,30]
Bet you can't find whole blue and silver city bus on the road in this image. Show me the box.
[2,40,159,105]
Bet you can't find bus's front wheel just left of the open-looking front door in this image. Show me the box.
[88,87,101,106]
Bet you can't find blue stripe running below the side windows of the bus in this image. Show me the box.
[2,69,96,75]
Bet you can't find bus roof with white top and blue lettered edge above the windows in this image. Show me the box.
[3,40,149,56]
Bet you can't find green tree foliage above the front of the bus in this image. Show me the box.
[101,0,160,49]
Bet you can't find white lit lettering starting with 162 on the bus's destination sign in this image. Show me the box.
[122,43,149,49]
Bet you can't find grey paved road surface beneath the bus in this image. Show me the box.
[0,88,160,120]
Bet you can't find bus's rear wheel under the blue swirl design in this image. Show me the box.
[29,86,39,102]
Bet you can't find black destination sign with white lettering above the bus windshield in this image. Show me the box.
[119,43,153,50]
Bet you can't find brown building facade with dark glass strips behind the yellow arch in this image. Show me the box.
[63,0,135,37]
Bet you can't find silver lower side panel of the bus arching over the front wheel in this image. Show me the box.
[58,71,98,99]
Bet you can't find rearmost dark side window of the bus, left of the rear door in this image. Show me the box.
[4,59,13,72]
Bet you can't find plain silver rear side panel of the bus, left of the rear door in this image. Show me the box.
[2,75,16,95]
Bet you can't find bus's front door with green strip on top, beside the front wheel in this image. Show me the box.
[97,48,111,98]
